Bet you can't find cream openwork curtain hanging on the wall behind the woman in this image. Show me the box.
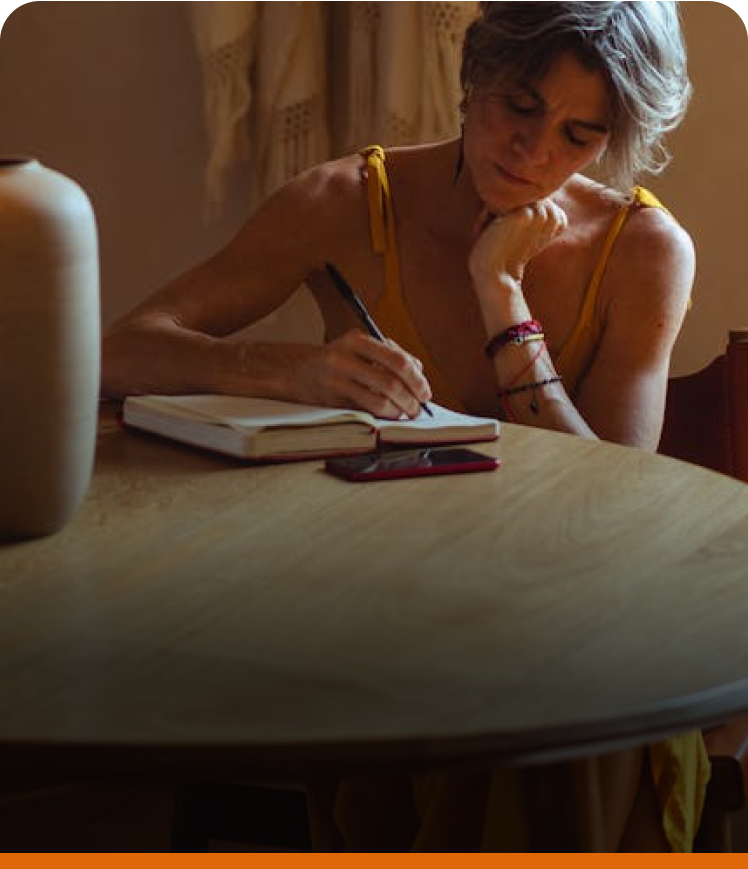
[190,0,477,213]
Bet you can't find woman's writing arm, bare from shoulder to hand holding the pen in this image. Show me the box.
[102,167,430,416]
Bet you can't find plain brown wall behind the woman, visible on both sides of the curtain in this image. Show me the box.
[0,0,748,370]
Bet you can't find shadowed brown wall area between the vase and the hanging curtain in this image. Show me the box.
[0,0,248,321]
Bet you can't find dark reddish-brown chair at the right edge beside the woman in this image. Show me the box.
[659,329,748,852]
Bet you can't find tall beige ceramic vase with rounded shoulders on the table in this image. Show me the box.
[0,156,101,542]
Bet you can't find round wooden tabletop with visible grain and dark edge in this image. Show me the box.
[0,412,748,775]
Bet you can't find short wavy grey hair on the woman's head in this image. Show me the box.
[460,0,692,188]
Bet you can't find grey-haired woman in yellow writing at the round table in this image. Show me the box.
[103,0,704,848]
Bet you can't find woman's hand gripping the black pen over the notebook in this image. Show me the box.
[288,329,431,419]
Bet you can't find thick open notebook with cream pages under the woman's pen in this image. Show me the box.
[123,395,499,461]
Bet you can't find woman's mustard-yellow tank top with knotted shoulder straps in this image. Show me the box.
[361,145,664,410]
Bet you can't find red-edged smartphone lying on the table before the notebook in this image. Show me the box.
[325,447,500,483]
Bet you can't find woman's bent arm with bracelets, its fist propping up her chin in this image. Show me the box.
[468,200,694,450]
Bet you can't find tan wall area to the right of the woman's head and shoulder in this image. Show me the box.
[652,0,748,370]
